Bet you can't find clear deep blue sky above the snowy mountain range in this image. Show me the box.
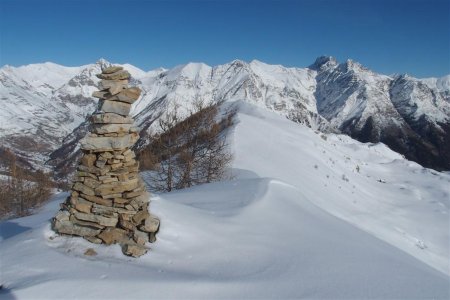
[0,0,450,77]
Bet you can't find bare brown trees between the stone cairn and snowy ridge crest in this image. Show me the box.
[139,102,235,192]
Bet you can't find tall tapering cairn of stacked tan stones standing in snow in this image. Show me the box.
[52,66,159,257]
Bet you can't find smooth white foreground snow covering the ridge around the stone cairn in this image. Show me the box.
[0,101,450,299]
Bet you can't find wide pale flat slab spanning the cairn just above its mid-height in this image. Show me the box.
[80,133,139,152]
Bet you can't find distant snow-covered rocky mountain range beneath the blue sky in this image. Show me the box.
[0,57,450,170]
